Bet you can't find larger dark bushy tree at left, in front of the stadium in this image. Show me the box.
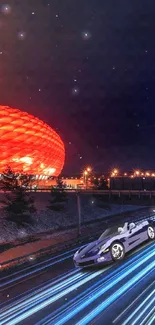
[0,167,36,227]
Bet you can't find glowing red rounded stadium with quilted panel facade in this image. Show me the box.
[0,106,65,176]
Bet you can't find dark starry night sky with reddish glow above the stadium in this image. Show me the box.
[0,0,155,174]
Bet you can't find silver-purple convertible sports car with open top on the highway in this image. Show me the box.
[73,219,155,267]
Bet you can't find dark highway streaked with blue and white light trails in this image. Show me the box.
[0,238,155,325]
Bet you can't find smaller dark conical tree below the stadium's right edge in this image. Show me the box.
[48,177,68,211]
